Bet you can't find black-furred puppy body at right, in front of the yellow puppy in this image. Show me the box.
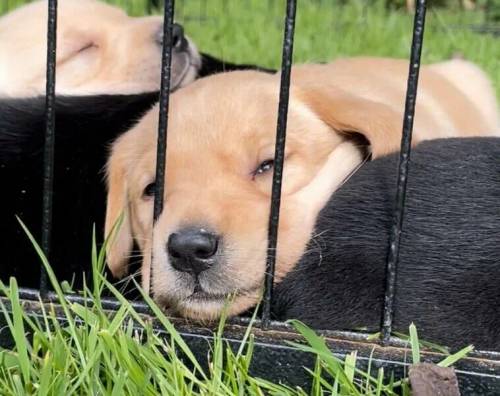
[274,138,500,350]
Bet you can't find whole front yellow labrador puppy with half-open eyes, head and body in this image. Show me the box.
[106,58,499,319]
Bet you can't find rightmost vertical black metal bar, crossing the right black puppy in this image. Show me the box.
[381,0,426,342]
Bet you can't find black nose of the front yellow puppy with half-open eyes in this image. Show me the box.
[167,228,219,275]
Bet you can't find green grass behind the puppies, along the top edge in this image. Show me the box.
[0,0,500,96]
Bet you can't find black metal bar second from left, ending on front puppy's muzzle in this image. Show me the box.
[149,0,175,290]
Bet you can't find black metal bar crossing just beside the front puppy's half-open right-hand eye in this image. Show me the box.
[262,0,297,328]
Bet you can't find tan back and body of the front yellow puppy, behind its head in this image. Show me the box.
[293,57,500,141]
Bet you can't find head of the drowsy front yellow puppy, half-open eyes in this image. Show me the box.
[106,72,412,319]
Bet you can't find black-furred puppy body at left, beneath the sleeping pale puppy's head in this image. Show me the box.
[0,93,158,287]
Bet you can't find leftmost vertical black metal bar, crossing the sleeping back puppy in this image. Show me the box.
[40,0,57,296]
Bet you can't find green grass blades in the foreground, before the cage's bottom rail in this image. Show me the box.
[0,220,472,396]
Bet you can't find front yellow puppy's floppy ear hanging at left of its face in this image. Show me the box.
[105,154,133,277]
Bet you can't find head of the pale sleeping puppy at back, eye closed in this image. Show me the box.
[0,0,200,95]
